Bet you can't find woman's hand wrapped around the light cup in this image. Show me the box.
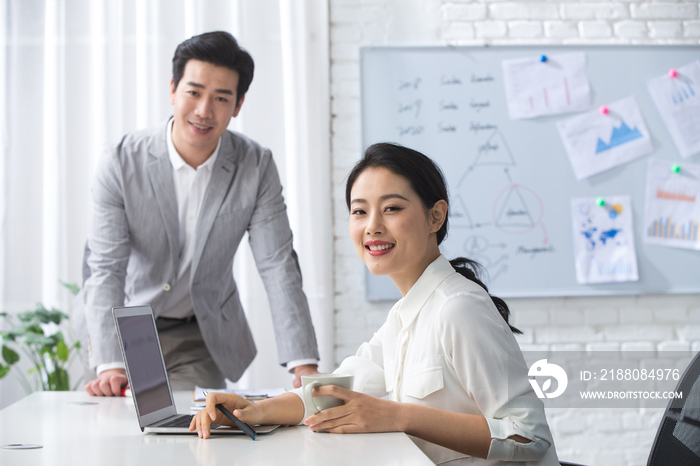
[304,385,404,434]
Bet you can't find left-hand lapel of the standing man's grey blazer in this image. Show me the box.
[146,127,180,274]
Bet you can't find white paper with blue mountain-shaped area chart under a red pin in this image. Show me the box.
[557,96,654,180]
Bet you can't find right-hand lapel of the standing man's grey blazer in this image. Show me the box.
[190,133,236,277]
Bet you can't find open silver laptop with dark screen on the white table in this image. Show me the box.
[112,306,279,435]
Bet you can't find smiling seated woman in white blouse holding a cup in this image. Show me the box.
[190,144,559,466]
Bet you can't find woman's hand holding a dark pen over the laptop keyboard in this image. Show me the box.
[190,393,260,438]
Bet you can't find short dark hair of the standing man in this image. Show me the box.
[173,31,255,105]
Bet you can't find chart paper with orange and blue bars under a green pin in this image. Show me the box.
[643,160,700,249]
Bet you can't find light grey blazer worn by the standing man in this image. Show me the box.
[75,124,318,381]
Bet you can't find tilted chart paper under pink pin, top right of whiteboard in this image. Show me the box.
[647,60,700,157]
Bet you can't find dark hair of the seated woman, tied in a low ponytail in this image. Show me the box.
[345,143,522,334]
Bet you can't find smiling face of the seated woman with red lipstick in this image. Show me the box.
[350,168,447,295]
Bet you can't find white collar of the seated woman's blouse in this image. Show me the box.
[396,254,455,328]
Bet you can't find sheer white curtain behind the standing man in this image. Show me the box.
[0,0,333,407]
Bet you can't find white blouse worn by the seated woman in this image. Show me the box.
[294,256,559,466]
